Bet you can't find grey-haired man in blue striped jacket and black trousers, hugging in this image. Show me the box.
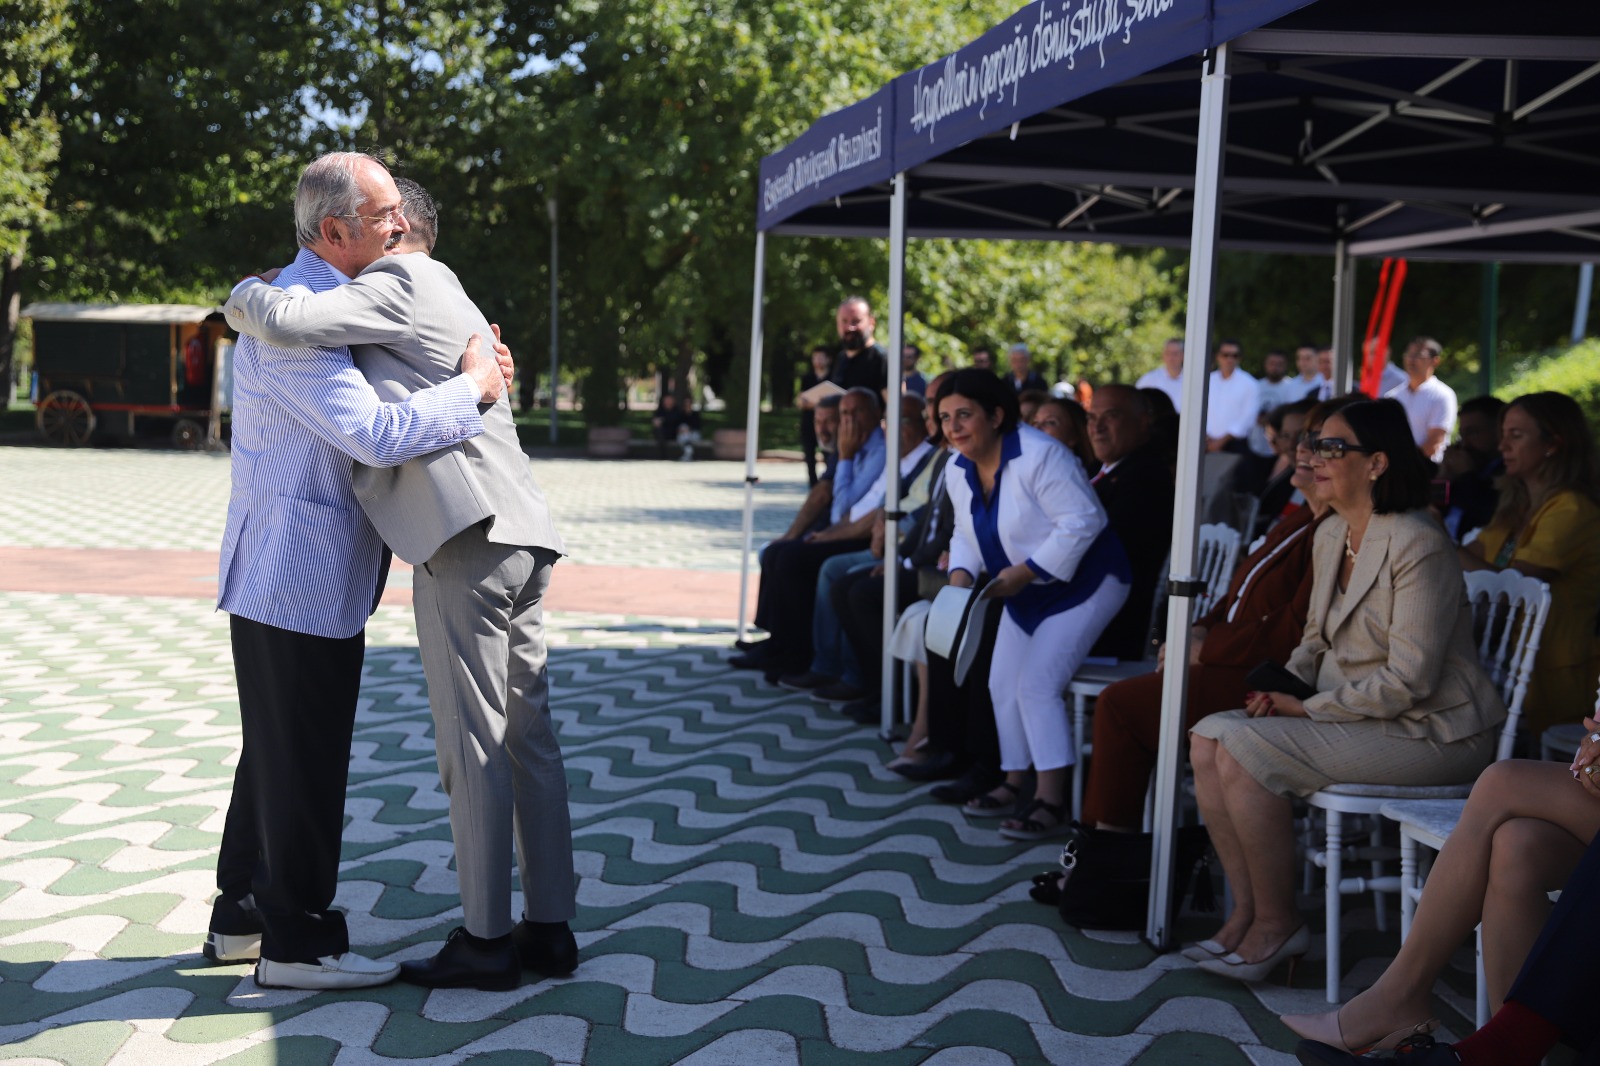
[205,152,510,989]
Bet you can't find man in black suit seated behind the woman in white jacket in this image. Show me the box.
[1090,384,1173,659]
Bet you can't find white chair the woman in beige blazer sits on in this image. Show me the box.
[1306,570,1550,1004]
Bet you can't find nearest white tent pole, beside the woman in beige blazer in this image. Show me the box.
[1144,43,1229,949]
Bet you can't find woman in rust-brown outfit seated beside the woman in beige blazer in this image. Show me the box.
[1083,397,1360,832]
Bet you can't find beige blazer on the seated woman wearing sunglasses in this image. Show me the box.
[1288,511,1506,743]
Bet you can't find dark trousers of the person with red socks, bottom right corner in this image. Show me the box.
[1506,819,1600,1063]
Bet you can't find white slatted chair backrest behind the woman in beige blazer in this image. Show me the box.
[1466,570,1550,759]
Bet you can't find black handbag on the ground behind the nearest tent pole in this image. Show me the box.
[1056,823,1216,930]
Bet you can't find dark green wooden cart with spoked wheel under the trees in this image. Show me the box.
[22,304,234,448]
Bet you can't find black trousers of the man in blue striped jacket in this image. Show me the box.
[216,615,366,962]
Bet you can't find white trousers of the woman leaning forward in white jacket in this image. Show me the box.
[989,578,1128,771]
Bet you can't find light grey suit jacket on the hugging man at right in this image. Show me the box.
[227,253,565,565]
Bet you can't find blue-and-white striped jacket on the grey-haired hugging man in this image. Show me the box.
[218,248,483,639]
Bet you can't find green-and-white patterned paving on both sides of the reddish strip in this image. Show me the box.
[0,450,1484,1066]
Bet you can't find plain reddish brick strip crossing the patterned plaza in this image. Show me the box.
[0,547,757,621]
